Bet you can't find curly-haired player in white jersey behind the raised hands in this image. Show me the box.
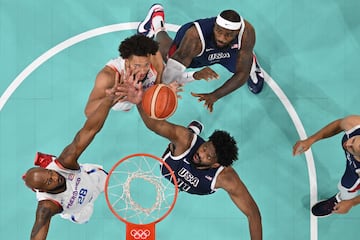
[85,34,164,117]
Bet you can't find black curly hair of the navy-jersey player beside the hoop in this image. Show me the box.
[209,130,238,167]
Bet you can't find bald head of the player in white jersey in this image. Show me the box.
[23,167,66,194]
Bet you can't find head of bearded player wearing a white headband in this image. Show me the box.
[214,10,243,48]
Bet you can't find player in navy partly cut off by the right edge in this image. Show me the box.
[293,115,360,216]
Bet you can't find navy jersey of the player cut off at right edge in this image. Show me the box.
[341,126,360,190]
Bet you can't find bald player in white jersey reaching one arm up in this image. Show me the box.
[23,71,134,240]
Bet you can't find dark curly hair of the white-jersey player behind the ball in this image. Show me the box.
[119,34,159,59]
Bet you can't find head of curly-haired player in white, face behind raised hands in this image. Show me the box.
[119,34,159,78]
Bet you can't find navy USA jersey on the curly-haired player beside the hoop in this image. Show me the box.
[161,134,224,195]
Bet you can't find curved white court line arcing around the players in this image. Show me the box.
[0,22,318,240]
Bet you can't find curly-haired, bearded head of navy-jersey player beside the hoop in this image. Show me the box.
[192,130,238,168]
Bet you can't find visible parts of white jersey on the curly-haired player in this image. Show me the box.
[106,57,157,111]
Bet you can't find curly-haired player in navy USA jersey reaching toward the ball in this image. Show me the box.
[118,83,262,240]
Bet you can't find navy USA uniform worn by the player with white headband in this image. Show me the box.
[169,17,245,73]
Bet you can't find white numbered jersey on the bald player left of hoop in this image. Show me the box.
[36,160,107,223]
